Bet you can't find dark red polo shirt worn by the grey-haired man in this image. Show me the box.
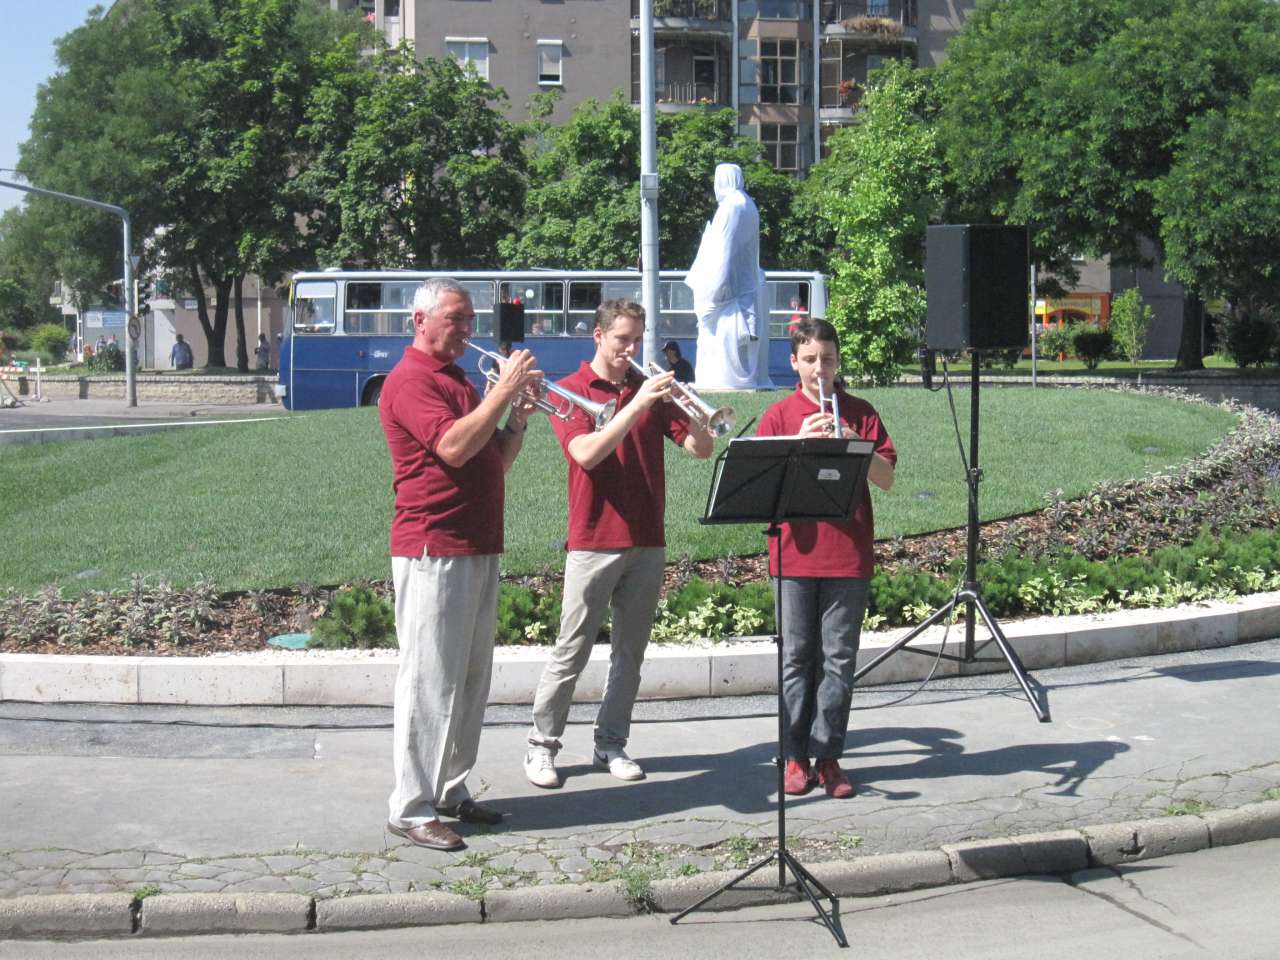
[379,347,504,557]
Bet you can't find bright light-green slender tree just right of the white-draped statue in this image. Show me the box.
[803,64,942,384]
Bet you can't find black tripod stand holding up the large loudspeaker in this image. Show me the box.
[854,349,1050,723]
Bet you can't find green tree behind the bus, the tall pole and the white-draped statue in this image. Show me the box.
[500,91,794,270]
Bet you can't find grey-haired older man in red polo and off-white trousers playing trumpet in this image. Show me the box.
[379,279,541,850]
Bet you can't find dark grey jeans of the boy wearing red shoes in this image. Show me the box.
[773,577,870,760]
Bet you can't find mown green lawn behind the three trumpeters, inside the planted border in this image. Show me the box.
[0,388,1234,590]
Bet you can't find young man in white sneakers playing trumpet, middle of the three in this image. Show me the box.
[525,300,712,787]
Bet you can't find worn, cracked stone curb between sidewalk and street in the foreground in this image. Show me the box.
[0,800,1280,940]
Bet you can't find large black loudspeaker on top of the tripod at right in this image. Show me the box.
[924,224,1030,351]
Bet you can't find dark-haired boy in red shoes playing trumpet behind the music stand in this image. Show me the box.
[758,317,897,797]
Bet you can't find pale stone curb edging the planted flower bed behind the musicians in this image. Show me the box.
[0,593,1280,707]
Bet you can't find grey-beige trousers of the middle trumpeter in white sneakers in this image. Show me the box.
[529,547,667,753]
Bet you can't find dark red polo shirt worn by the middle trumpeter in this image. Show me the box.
[550,362,689,550]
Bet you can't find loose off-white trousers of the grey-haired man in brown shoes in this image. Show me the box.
[389,553,498,827]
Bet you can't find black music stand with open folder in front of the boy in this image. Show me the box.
[671,436,874,947]
